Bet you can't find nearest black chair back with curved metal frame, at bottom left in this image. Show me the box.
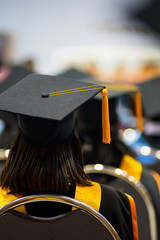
[0,195,120,240]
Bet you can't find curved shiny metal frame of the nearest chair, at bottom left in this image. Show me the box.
[0,194,121,240]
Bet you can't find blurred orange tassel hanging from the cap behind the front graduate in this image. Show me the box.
[135,91,143,131]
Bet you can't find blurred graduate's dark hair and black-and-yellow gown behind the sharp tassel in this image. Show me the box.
[76,92,160,230]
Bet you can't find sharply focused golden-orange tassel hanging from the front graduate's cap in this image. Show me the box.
[101,88,111,143]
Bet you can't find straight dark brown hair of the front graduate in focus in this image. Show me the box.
[1,130,92,194]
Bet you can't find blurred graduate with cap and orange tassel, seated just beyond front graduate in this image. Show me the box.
[58,69,160,235]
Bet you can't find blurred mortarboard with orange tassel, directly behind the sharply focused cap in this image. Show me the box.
[58,69,143,131]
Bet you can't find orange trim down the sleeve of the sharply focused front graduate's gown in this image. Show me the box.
[126,194,139,240]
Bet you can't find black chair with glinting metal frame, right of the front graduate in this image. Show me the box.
[85,164,158,240]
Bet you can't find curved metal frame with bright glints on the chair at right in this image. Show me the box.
[84,164,158,240]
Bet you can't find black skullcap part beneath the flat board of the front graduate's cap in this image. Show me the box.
[18,113,75,146]
